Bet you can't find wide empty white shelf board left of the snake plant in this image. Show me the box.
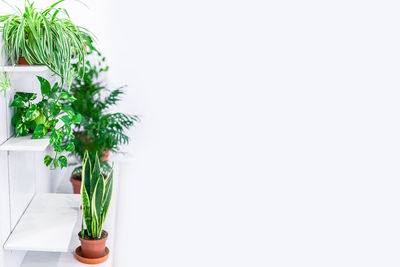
[4,193,81,252]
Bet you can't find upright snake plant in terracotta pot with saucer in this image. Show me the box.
[75,152,113,264]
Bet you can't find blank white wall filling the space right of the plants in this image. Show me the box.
[4,0,400,267]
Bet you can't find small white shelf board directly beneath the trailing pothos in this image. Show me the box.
[0,135,50,151]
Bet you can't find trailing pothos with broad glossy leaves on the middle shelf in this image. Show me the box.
[11,76,82,168]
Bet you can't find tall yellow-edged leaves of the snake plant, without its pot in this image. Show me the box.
[81,152,114,239]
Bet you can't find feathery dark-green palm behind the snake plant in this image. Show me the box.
[70,47,138,193]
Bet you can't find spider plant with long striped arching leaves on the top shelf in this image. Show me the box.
[0,0,92,85]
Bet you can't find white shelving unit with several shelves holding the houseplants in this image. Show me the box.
[0,52,116,267]
